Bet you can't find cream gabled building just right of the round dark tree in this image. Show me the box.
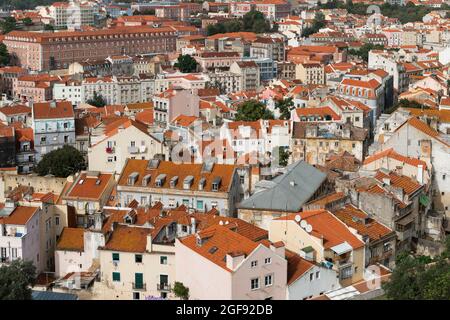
[88,118,165,174]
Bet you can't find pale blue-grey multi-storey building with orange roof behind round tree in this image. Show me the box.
[32,101,75,162]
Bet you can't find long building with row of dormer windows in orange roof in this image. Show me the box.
[117,159,240,216]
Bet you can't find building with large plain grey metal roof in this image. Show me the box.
[238,161,327,230]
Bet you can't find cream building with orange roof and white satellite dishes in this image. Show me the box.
[269,210,365,286]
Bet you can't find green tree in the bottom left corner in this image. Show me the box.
[0,259,36,300]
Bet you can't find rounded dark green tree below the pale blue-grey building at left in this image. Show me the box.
[35,145,86,178]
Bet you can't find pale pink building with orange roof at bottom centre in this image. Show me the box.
[175,223,287,300]
